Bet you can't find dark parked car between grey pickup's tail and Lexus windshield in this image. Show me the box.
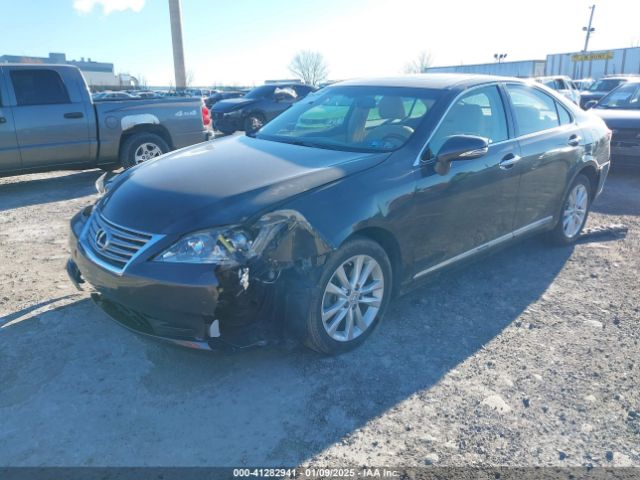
[211,83,316,135]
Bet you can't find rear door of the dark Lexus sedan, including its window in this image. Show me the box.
[506,83,584,229]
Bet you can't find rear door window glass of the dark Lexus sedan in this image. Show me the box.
[507,84,560,135]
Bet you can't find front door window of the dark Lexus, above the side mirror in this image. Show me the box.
[429,86,509,155]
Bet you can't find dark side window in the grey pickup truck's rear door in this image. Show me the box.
[11,69,70,106]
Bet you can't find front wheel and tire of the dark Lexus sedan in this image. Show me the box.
[292,237,393,355]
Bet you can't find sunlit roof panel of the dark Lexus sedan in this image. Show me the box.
[330,73,525,89]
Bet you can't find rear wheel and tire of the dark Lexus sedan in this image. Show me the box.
[549,174,591,245]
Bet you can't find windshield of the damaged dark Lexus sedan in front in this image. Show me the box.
[256,87,441,152]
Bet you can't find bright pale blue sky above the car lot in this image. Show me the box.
[0,0,640,85]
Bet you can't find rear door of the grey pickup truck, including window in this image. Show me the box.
[6,67,91,169]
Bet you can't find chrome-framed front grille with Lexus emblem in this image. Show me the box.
[87,212,153,271]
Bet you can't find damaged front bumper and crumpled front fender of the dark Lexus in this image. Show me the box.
[67,205,332,350]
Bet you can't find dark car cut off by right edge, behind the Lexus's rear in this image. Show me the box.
[587,78,640,167]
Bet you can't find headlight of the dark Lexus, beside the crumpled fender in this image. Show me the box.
[156,228,252,267]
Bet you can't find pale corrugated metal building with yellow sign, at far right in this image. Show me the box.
[545,47,640,79]
